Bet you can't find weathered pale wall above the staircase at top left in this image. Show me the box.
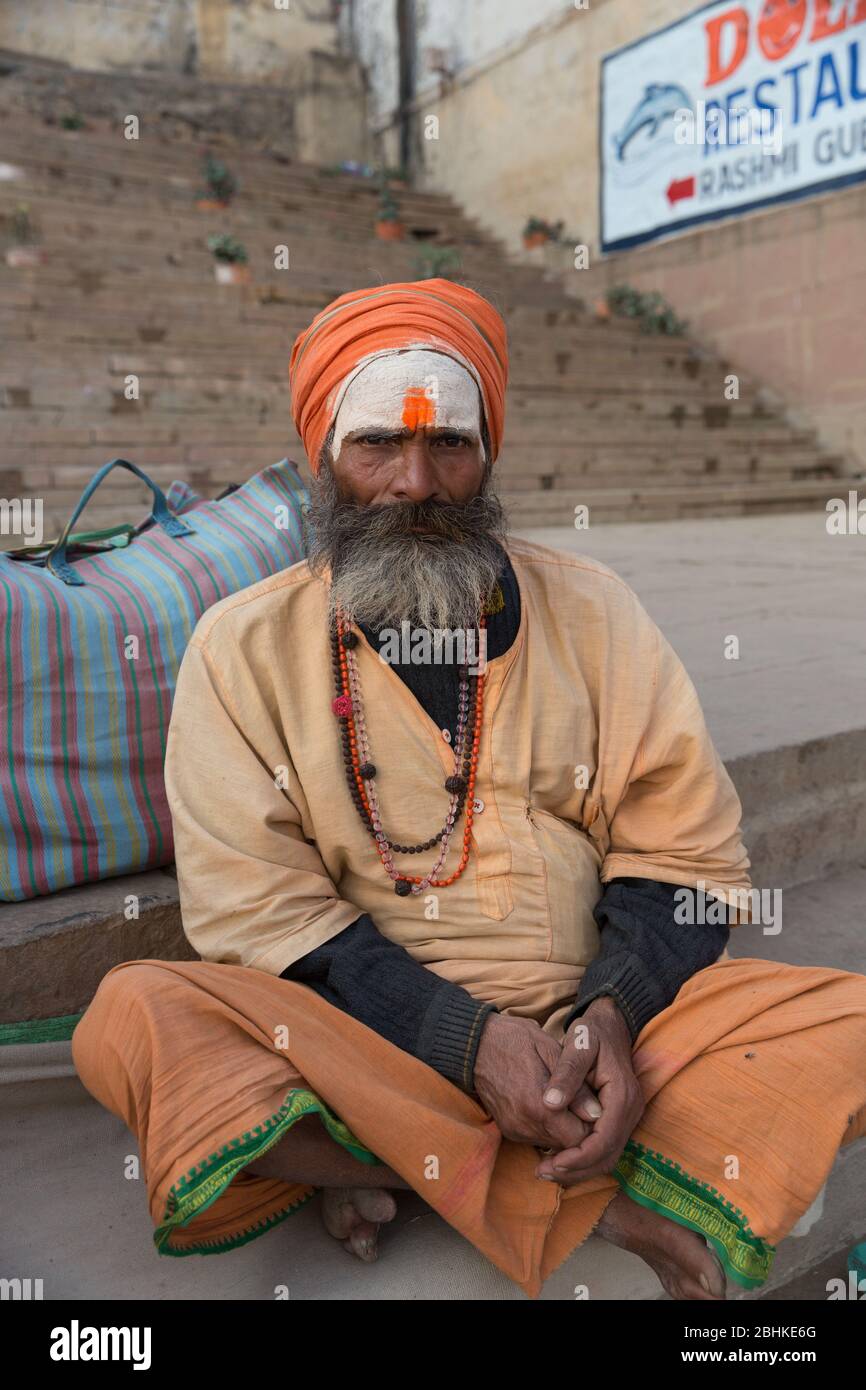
[0,0,338,82]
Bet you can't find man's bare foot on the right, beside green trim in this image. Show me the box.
[595,1191,727,1301]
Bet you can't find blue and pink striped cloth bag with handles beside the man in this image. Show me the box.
[0,459,309,902]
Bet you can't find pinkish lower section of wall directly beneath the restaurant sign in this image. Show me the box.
[578,185,866,464]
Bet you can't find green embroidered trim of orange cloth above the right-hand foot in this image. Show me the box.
[613,1140,776,1289]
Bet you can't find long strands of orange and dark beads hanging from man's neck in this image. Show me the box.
[331,611,489,897]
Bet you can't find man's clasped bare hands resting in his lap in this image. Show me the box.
[474,997,644,1187]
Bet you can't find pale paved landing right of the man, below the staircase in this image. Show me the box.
[520,513,866,759]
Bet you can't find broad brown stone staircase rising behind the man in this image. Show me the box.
[0,73,848,548]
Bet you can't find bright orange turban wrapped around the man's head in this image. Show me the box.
[289,279,509,473]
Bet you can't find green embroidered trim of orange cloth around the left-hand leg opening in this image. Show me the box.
[153,1090,381,1255]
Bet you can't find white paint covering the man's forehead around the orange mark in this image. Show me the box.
[334,342,484,459]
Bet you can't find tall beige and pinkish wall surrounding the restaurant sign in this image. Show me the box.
[348,0,866,464]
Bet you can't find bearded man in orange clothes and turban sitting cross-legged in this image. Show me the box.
[74,281,866,1300]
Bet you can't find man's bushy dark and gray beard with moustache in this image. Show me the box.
[304,459,506,631]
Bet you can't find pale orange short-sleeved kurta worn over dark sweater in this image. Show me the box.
[165,541,749,1031]
